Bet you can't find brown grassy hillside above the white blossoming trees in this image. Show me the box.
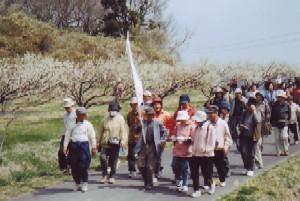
[0,12,173,63]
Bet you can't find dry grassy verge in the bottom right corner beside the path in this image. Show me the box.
[219,154,300,201]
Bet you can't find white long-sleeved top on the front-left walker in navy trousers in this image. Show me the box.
[64,120,96,148]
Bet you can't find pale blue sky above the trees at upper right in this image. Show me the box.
[165,0,300,67]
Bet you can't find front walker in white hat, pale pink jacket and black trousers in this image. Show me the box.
[190,111,216,197]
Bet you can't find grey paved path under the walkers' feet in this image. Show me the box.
[15,136,300,201]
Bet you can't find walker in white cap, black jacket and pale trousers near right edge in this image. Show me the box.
[270,91,291,156]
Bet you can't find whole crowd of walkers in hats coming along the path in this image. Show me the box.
[58,78,300,197]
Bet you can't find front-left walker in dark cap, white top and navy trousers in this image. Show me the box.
[64,107,96,192]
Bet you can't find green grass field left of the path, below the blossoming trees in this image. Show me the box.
[0,95,203,200]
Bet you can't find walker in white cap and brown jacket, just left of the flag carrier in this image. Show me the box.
[127,97,142,178]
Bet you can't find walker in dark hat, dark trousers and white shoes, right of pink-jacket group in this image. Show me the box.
[239,97,261,177]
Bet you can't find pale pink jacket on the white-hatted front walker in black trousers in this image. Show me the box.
[192,122,217,157]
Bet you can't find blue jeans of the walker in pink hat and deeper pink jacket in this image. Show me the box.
[171,156,189,186]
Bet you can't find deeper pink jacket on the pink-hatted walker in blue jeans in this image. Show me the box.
[173,121,194,157]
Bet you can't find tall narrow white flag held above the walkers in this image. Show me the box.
[126,33,143,105]
